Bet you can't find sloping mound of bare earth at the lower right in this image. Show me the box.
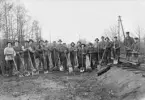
[98,67,145,100]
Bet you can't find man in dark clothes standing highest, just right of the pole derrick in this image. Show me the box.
[124,32,134,60]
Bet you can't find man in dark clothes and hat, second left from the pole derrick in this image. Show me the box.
[104,37,112,64]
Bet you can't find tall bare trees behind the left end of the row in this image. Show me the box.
[0,0,41,42]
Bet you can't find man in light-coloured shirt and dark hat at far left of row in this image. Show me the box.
[4,41,16,76]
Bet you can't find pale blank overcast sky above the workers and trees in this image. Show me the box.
[21,0,145,43]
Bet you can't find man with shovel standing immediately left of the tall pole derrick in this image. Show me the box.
[112,36,120,61]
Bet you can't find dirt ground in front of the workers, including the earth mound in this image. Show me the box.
[0,67,145,100]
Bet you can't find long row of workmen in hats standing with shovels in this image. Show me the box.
[2,32,139,77]
